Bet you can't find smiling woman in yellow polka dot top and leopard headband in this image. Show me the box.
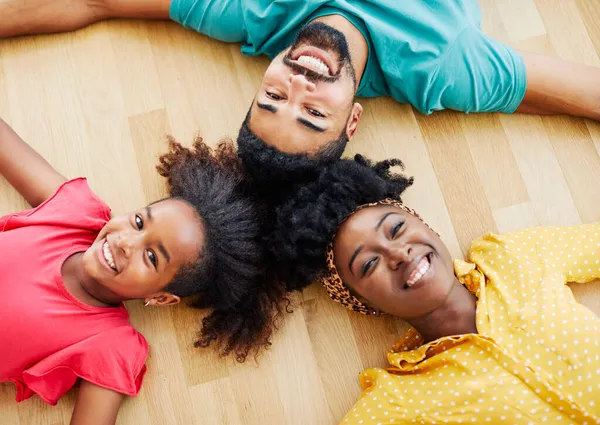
[272,156,600,425]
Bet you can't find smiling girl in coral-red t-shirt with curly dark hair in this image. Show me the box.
[0,120,282,425]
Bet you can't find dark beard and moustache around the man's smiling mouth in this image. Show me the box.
[283,22,357,88]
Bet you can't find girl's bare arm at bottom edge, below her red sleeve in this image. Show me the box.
[71,380,125,425]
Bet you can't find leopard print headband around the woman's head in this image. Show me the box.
[319,198,433,314]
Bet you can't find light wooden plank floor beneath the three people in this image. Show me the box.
[0,0,600,425]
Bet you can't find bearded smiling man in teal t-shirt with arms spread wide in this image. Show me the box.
[0,0,600,197]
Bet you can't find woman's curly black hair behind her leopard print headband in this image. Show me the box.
[267,155,413,291]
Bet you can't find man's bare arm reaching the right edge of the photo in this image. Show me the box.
[517,52,600,121]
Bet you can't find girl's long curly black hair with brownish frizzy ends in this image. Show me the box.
[157,137,285,362]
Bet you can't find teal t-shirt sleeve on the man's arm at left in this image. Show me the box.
[169,0,246,43]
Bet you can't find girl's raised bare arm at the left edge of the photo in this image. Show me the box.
[0,118,67,207]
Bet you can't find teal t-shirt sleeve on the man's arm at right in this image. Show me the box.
[419,25,526,113]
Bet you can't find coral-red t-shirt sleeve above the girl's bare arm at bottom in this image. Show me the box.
[20,326,148,405]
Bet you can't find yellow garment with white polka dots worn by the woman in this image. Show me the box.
[342,223,600,425]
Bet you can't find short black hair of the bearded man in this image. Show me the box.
[237,109,348,206]
